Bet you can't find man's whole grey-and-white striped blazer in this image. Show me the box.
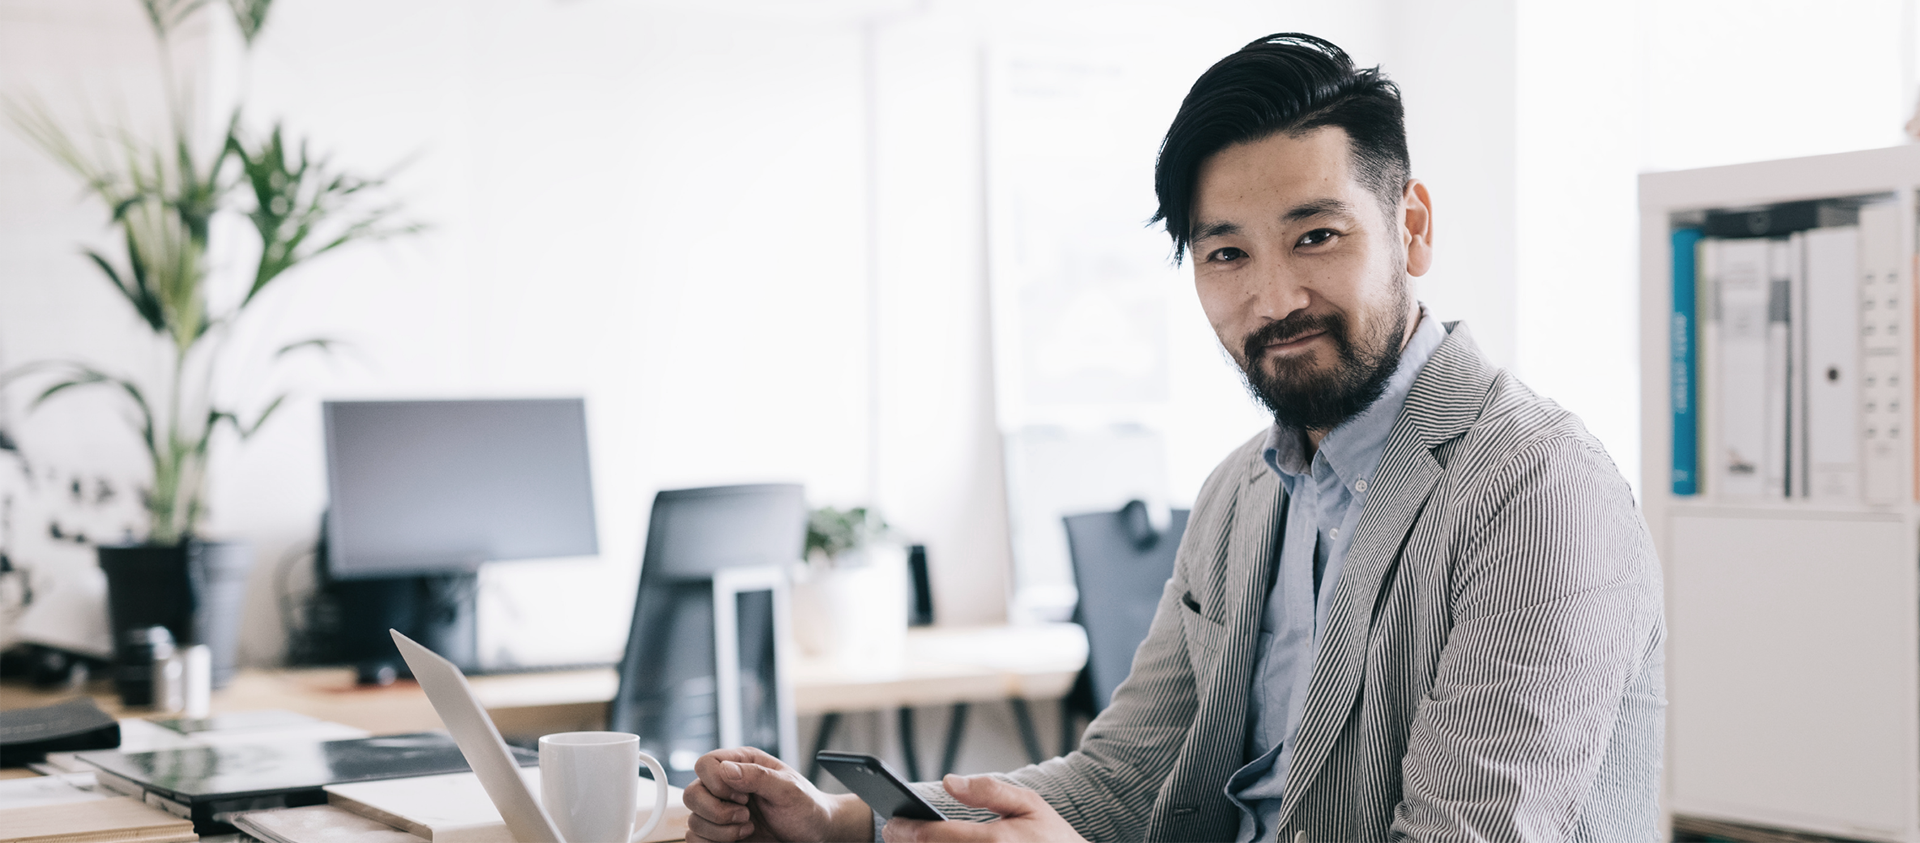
[922,323,1665,843]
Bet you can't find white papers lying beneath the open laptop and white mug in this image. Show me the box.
[322,766,687,843]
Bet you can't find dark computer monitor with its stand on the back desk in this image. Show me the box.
[321,397,599,678]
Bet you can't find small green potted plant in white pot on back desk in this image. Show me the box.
[793,507,908,664]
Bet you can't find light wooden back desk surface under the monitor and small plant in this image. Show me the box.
[0,624,1087,735]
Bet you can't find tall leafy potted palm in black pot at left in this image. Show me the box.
[0,0,419,686]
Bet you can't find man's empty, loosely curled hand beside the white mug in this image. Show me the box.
[685,747,874,843]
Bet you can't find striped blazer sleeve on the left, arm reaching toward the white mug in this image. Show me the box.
[914,447,1246,843]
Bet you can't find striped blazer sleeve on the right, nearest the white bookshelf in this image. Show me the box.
[1392,436,1663,841]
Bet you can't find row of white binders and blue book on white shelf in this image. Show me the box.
[1668,200,1916,503]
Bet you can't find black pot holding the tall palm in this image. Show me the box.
[96,540,253,687]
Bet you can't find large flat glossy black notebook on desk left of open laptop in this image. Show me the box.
[79,732,540,833]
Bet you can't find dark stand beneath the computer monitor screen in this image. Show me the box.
[324,574,480,686]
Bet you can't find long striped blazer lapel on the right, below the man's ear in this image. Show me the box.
[1281,323,1494,822]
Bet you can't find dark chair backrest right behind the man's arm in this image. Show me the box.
[1064,501,1188,712]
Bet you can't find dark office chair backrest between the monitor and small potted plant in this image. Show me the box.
[607,484,806,785]
